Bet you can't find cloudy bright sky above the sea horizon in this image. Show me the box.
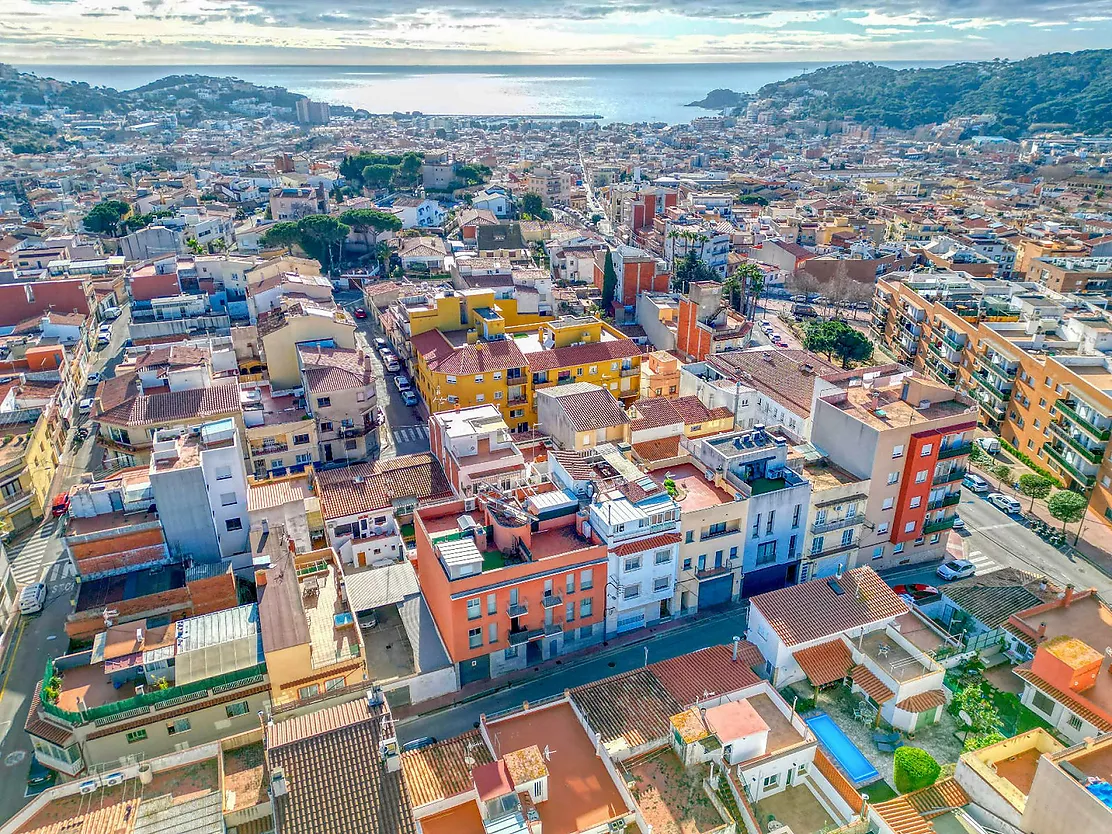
[0,0,1112,67]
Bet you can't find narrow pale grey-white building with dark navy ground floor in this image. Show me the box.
[679,425,811,596]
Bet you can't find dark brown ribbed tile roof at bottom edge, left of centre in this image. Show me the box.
[267,698,417,834]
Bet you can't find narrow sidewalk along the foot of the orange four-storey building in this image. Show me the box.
[391,605,748,721]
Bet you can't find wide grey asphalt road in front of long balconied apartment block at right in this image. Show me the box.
[884,488,1112,595]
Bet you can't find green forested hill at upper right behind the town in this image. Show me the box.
[757,49,1112,137]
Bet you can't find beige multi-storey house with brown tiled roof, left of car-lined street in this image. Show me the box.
[297,345,378,463]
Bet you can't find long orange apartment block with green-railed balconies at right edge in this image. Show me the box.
[873,274,1112,524]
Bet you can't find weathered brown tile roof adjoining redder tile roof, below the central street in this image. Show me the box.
[570,668,683,749]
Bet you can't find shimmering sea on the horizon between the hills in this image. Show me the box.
[19,61,941,123]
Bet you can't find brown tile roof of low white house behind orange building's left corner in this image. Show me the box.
[316,453,453,518]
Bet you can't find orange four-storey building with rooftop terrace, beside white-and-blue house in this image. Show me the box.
[414,490,607,686]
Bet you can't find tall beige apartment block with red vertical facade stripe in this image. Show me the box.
[811,365,976,567]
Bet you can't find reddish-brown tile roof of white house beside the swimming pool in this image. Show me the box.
[749,566,909,646]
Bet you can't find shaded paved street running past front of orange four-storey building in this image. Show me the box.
[398,608,745,743]
